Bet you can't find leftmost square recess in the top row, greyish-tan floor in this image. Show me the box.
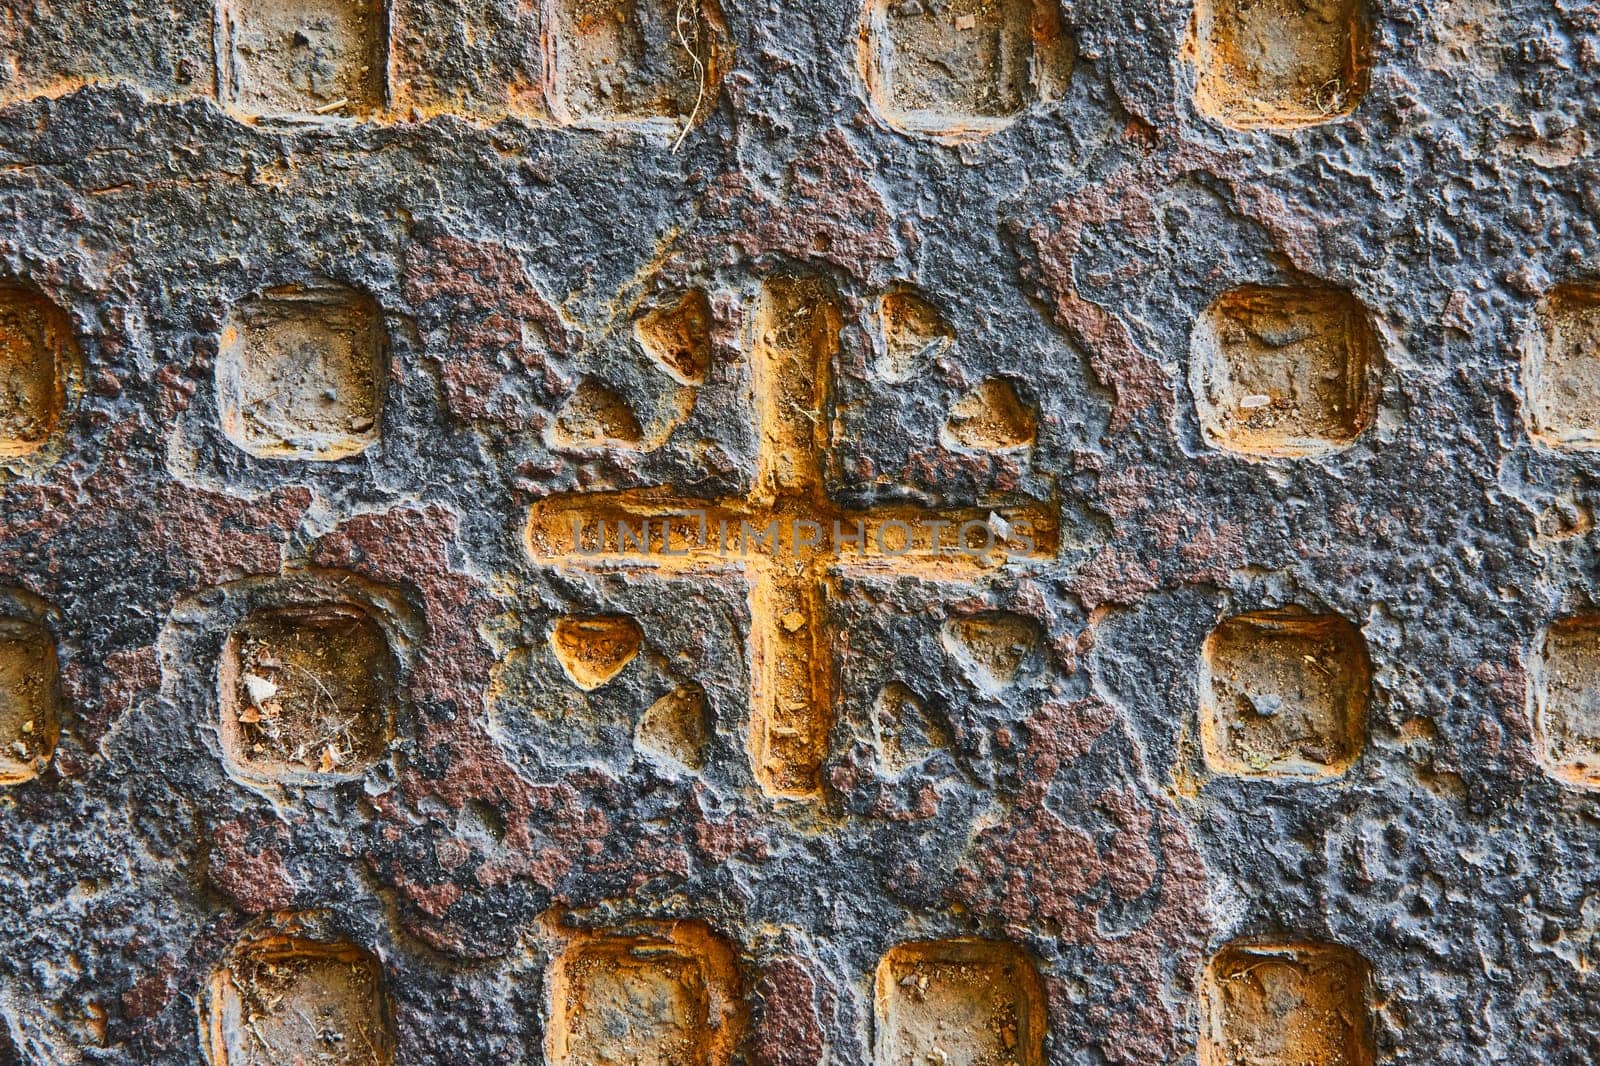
[218,0,389,120]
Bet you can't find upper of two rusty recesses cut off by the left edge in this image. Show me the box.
[0,285,75,459]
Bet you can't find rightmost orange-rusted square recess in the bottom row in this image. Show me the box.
[1200,944,1373,1066]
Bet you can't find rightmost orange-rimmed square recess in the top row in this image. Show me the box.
[1190,0,1370,130]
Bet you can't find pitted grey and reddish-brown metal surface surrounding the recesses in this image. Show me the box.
[0,0,1600,1066]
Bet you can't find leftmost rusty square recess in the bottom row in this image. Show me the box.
[205,936,394,1066]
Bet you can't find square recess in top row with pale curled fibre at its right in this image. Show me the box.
[544,0,725,125]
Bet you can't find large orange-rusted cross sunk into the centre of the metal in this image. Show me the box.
[528,277,1059,799]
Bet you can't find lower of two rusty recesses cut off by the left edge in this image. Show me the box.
[0,618,61,784]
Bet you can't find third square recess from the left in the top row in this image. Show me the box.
[861,0,1070,138]
